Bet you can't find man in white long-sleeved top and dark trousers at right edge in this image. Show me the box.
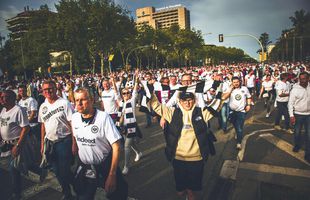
[288,72,310,163]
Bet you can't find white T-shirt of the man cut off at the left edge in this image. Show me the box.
[0,105,29,141]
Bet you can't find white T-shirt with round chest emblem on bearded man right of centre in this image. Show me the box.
[229,86,251,112]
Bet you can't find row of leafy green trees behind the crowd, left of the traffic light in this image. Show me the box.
[0,0,260,76]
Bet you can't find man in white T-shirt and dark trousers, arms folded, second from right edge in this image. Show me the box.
[274,73,293,133]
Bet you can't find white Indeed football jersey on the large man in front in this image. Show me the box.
[72,110,122,164]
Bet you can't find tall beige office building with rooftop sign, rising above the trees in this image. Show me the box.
[136,5,190,29]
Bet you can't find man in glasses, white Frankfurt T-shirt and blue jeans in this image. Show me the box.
[38,80,74,200]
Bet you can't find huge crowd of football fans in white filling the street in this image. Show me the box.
[0,63,310,200]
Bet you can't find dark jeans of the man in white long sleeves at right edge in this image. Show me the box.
[294,114,310,159]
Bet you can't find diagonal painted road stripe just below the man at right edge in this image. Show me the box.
[259,133,310,166]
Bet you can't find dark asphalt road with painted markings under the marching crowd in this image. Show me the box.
[0,100,310,200]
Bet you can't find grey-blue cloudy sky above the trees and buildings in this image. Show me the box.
[0,0,310,58]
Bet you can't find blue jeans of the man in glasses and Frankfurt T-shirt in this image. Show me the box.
[51,136,73,197]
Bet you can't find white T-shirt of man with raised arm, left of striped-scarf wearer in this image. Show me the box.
[101,89,118,114]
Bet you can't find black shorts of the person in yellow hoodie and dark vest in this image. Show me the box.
[172,160,204,192]
